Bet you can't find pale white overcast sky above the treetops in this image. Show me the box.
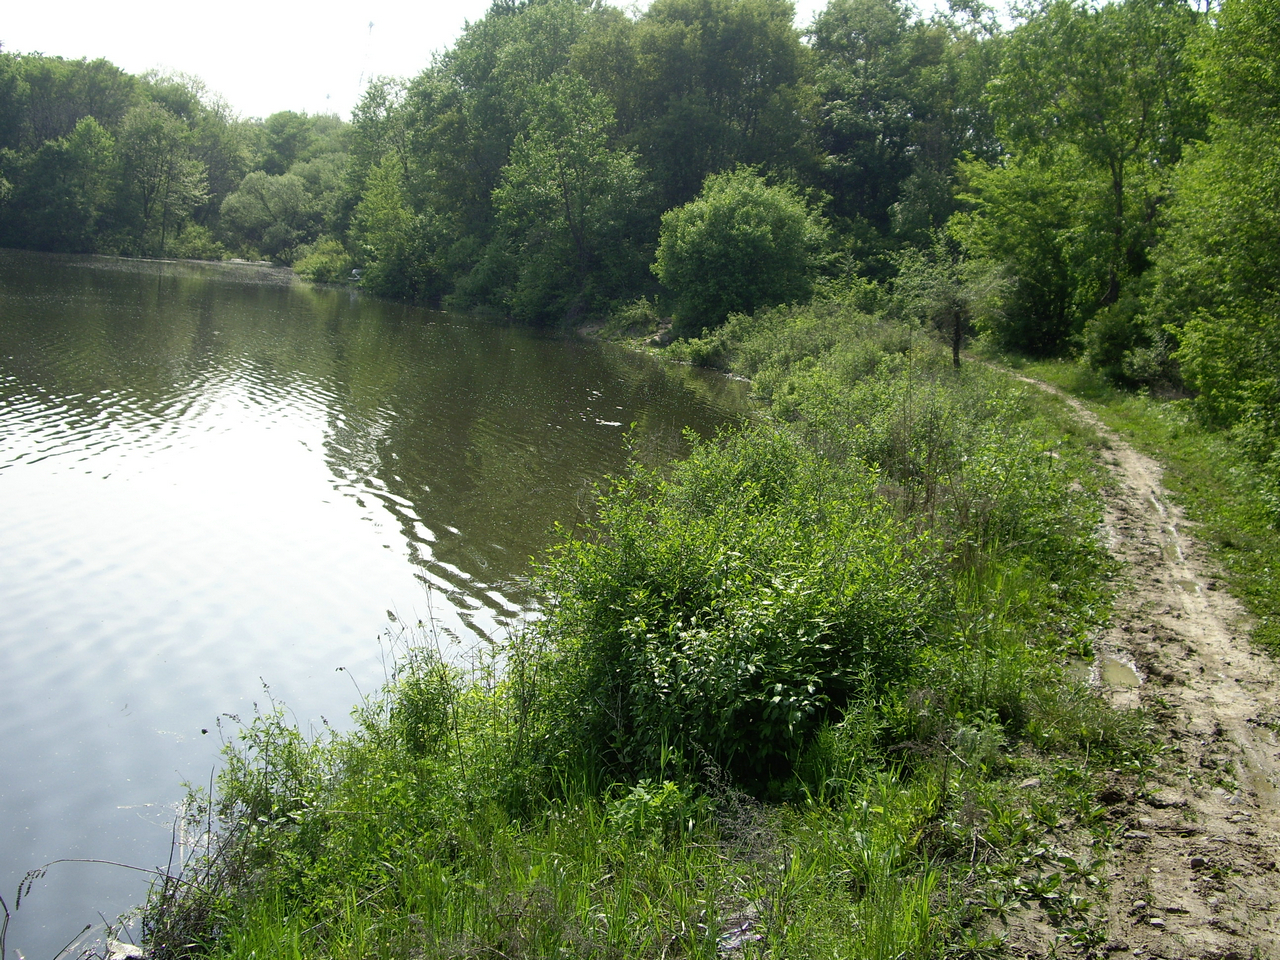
[0,0,844,119]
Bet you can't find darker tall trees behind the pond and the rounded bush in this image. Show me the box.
[0,0,998,305]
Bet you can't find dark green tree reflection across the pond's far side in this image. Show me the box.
[0,255,745,634]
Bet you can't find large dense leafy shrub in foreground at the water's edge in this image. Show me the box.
[536,426,943,788]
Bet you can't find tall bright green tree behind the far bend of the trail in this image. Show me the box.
[970,0,1204,348]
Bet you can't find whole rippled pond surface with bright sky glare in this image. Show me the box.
[0,251,745,960]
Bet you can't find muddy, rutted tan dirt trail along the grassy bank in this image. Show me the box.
[1037,384,1280,960]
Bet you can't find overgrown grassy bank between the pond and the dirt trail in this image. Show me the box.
[143,305,1148,960]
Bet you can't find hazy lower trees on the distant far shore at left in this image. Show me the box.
[0,52,349,262]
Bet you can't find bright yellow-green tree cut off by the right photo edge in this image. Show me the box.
[1148,0,1280,506]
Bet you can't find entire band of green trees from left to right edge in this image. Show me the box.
[0,0,1280,496]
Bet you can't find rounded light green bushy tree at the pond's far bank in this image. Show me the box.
[653,168,826,333]
